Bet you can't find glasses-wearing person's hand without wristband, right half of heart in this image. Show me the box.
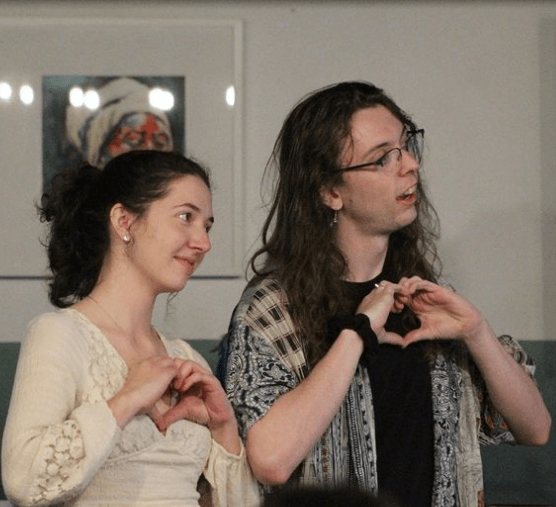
[396,276,485,346]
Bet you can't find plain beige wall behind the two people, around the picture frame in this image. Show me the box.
[0,0,556,341]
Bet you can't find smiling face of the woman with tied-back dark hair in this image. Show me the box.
[128,175,214,294]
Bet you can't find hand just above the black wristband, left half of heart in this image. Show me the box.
[356,280,404,345]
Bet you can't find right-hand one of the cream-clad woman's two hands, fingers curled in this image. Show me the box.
[155,358,235,432]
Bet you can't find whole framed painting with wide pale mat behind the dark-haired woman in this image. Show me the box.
[0,18,244,278]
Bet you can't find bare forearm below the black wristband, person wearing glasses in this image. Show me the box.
[246,330,363,484]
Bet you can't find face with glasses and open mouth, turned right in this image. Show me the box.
[323,106,419,240]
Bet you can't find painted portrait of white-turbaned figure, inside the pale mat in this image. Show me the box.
[42,76,185,191]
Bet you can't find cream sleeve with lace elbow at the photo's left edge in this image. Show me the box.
[2,314,119,506]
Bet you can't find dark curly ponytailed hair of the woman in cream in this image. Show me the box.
[37,150,210,308]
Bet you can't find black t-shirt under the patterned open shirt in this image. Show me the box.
[346,276,434,507]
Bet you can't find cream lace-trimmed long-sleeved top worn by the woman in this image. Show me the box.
[2,309,259,507]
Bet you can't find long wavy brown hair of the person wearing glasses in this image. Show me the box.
[249,82,440,363]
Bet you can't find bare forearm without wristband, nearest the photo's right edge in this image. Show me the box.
[465,321,551,445]
